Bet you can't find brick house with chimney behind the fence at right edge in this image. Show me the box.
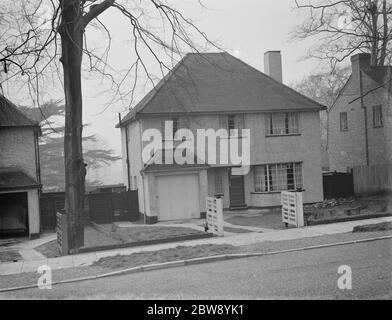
[327,53,392,172]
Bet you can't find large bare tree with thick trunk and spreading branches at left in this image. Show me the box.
[0,0,212,250]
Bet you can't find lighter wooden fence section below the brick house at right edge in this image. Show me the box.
[353,165,392,196]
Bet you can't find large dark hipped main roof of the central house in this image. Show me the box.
[121,52,325,124]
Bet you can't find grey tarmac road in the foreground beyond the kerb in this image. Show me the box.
[0,239,392,299]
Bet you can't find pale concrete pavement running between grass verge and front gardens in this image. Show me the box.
[0,217,392,275]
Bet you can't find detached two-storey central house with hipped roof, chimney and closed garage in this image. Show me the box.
[117,51,325,223]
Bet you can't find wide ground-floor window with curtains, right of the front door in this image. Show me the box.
[254,162,302,192]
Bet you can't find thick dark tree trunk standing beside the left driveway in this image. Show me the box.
[59,0,86,251]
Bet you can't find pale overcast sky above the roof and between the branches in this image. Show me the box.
[6,0,330,184]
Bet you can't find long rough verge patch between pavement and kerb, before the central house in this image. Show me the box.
[93,244,240,269]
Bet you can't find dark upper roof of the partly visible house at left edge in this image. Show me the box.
[0,94,38,127]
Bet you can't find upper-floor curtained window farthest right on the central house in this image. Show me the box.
[266,112,299,136]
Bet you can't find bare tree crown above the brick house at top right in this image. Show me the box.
[292,0,392,68]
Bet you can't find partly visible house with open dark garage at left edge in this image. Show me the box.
[0,95,41,238]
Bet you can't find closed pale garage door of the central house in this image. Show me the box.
[156,174,200,221]
